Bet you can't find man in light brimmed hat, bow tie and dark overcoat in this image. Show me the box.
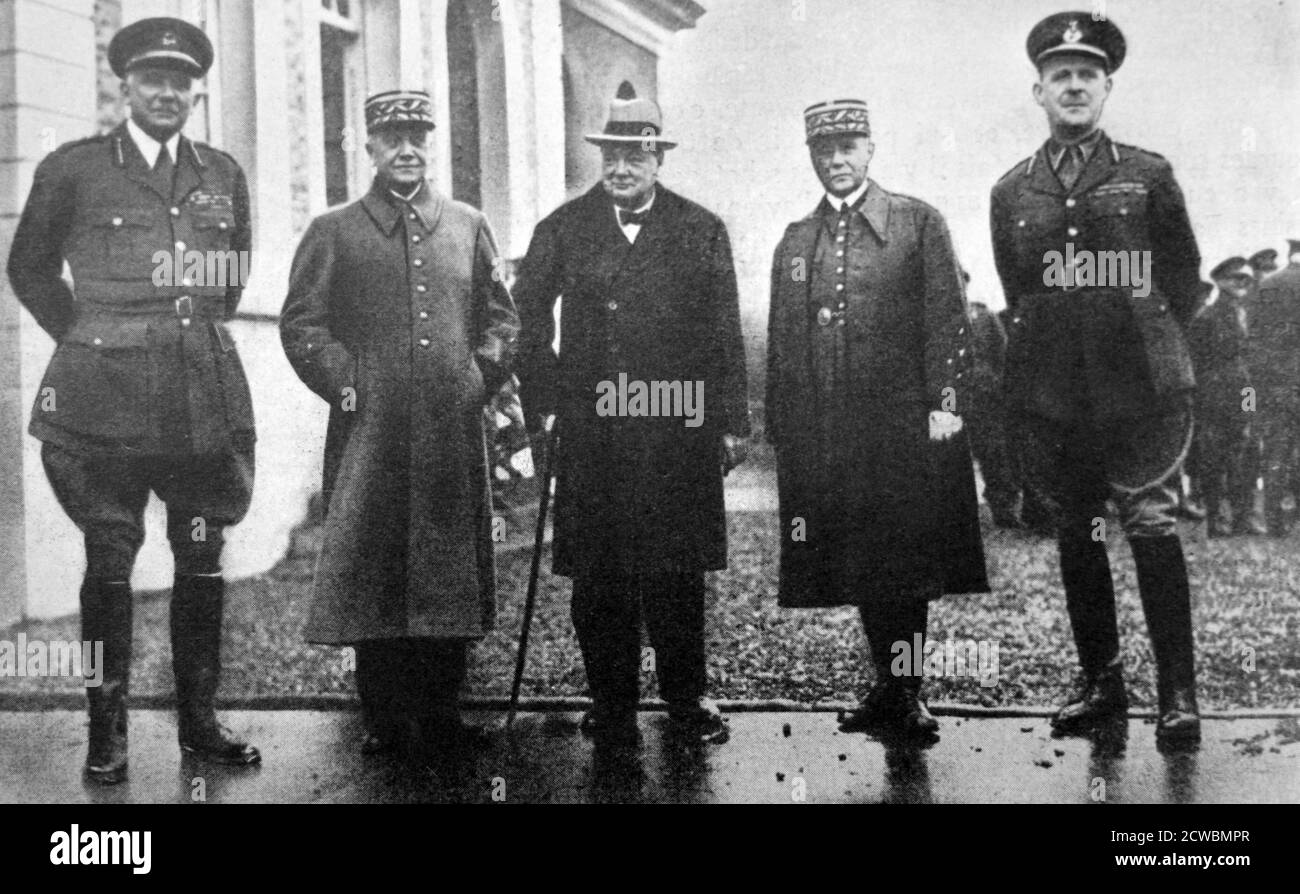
[515,92,749,752]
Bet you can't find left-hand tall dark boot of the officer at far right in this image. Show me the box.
[1052,526,1128,733]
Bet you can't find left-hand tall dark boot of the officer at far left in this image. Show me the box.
[81,577,131,785]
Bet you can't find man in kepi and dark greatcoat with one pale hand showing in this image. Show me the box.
[766,100,988,741]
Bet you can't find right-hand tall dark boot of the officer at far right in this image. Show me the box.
[1131,534,1201,745]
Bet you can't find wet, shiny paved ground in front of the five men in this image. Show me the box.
[0,709,1300,803]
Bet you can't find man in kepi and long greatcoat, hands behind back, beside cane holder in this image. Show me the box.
[281,91,519,760]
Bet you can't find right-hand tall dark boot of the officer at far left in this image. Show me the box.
[172,574,261,765]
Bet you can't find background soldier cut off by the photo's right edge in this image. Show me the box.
[1251,239,1300,537]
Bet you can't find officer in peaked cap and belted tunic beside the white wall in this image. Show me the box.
[9,18,260,784]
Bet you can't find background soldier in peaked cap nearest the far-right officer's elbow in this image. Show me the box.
[1187,257,1260,537]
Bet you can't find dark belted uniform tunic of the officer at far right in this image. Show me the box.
[991,134,1203,422]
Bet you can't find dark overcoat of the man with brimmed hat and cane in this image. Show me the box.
[514,185,749,576]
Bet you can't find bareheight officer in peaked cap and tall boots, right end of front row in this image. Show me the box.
[992,12,1203,745]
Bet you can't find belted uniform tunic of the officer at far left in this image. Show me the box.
[9,123,254,456]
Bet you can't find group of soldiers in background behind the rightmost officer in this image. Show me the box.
[965,239,1300,538]
